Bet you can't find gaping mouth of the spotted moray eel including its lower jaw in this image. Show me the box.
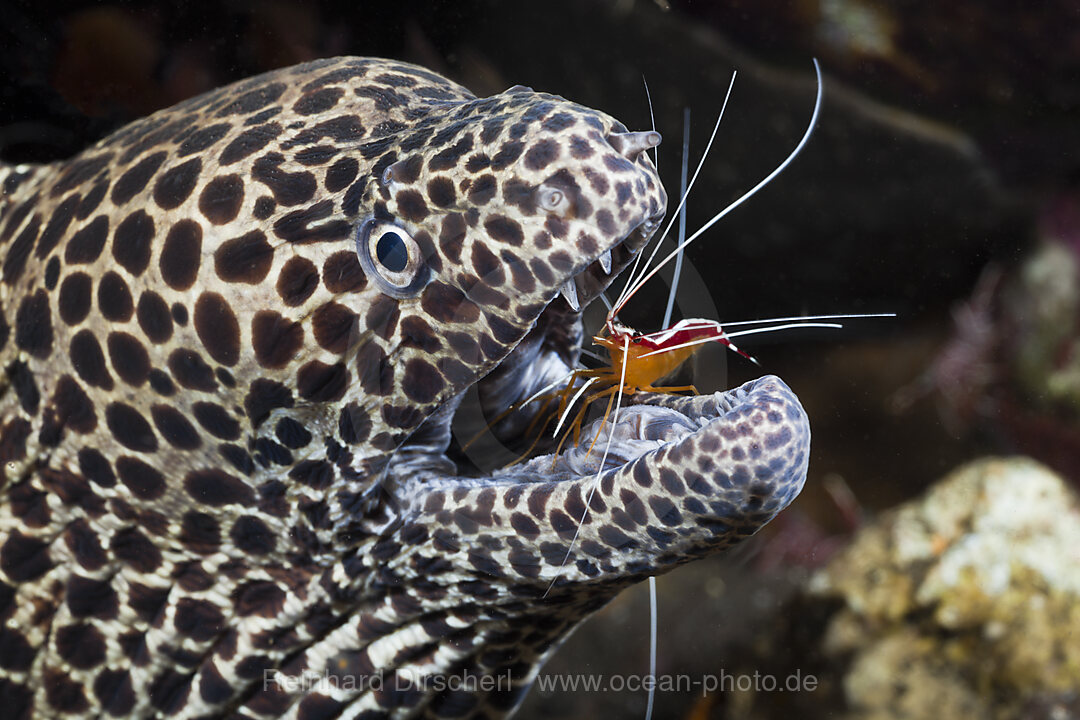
[387,211,810,596]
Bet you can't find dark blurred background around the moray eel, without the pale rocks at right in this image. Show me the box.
[0,0,1080,718]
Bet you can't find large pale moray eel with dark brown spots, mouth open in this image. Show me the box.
[0,58,810,718]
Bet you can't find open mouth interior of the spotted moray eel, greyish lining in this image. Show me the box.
[419,220,809,504]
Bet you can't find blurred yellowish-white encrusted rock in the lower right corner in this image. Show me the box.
[809,459,1080,719]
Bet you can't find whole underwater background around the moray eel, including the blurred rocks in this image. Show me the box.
[0,0,1080,720]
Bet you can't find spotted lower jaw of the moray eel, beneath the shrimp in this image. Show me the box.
[393,376,810,594]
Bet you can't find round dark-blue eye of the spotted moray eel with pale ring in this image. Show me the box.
[356,218,431,298]
